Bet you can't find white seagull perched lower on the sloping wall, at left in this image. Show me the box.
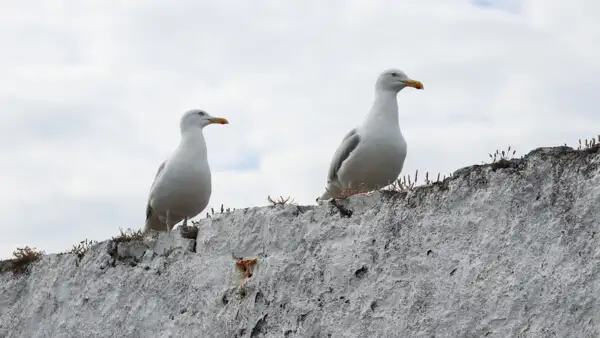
[144,109,229,232]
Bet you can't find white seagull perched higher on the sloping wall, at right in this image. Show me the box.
[320,69,423,200]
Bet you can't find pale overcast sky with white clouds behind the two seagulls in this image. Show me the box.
[0,0,600,257]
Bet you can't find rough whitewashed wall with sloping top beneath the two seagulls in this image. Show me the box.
[0,147,600,337]
